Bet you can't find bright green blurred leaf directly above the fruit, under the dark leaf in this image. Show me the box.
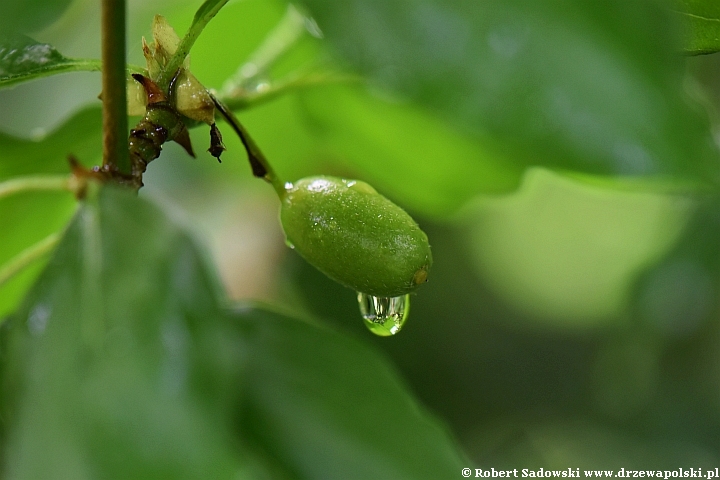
[303,87,522,217]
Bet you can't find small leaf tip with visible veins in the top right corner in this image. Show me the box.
[676,0,720,55]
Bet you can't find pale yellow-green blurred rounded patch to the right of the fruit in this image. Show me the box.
[459,168,696,327]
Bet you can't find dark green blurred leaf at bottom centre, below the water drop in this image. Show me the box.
[238,311,470,480]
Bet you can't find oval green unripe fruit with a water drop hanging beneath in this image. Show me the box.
[280,176,432,297]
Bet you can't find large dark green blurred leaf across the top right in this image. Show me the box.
[305,0,719,183]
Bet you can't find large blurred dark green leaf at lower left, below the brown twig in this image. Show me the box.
[4,189,264,478]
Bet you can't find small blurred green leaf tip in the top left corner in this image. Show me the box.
[0,0,72,37]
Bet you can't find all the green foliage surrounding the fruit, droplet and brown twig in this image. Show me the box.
[0,0,720,479]
